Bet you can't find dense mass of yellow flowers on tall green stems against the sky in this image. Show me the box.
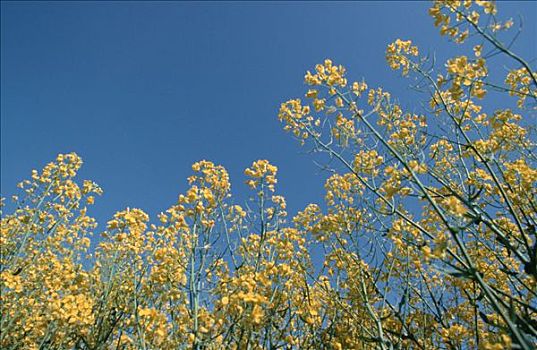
[0,0,537,349]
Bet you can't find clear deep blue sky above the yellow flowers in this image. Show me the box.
[1,1,537,228]
